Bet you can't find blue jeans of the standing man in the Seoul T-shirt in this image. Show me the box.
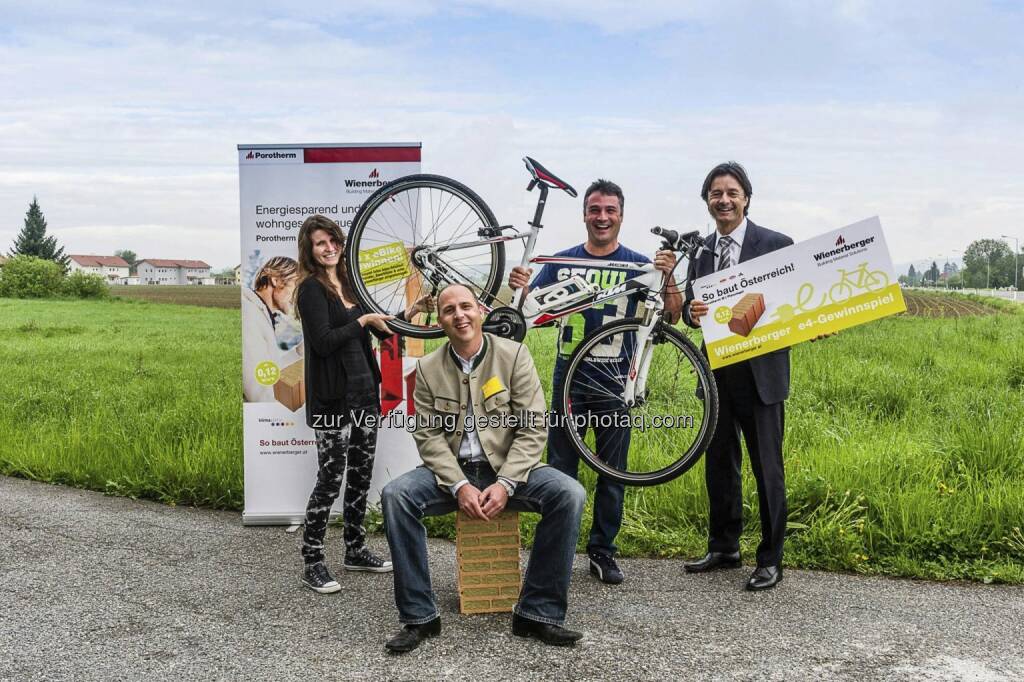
[548,358,632,556]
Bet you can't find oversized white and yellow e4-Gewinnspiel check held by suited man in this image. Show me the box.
[693,217,906,368]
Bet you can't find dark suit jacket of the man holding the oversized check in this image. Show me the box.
[683,218,793,404]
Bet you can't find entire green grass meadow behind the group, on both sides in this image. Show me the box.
[0,290,1024,583]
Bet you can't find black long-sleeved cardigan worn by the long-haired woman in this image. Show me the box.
[297,278,391,429]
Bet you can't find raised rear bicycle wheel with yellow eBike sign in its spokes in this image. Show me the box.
[345,174,505,338]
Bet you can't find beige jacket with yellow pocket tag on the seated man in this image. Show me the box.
[413,334,548,488]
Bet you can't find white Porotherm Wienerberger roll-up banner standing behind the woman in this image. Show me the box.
[239,142,421,524]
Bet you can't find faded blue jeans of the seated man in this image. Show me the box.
[381,458,587,626]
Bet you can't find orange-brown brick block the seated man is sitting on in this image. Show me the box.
[456,511,522,613]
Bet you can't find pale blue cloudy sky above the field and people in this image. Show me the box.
[0,0,1024,269]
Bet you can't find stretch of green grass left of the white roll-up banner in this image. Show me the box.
[0,299,243,508]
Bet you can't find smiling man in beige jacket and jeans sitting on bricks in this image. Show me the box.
[381,285,586,652]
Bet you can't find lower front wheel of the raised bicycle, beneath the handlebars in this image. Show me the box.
[553,317,718,485]
